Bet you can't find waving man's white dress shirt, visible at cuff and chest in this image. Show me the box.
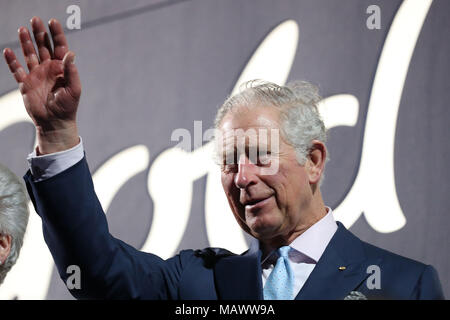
[27,137,337,297]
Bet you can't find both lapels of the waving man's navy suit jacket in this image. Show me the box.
[214,222,376,300]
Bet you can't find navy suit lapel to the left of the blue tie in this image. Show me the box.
[214,242,263,300]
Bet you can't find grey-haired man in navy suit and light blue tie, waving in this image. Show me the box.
[4,17,443,300]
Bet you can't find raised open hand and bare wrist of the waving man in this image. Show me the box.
[3,17,81,154]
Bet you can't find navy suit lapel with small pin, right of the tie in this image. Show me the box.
[296,222,369,300]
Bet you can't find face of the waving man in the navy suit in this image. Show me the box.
[219,107,312,240]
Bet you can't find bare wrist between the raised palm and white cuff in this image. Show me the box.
[36,124,80,155]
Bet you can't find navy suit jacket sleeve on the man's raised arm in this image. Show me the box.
[24,157,193,299]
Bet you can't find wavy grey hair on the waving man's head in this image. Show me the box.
[215,80,328,178]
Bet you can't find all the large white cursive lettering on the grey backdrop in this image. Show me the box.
[0,0,432,299]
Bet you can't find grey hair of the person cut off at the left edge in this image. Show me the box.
[0,164,29,284]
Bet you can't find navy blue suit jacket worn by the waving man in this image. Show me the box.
[24,158,443,300]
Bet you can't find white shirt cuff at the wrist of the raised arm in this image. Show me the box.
[27,137,84,182]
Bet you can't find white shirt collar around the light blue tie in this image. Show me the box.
[261,207,337,264]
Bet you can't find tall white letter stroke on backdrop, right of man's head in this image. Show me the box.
[334,0,432,233]
